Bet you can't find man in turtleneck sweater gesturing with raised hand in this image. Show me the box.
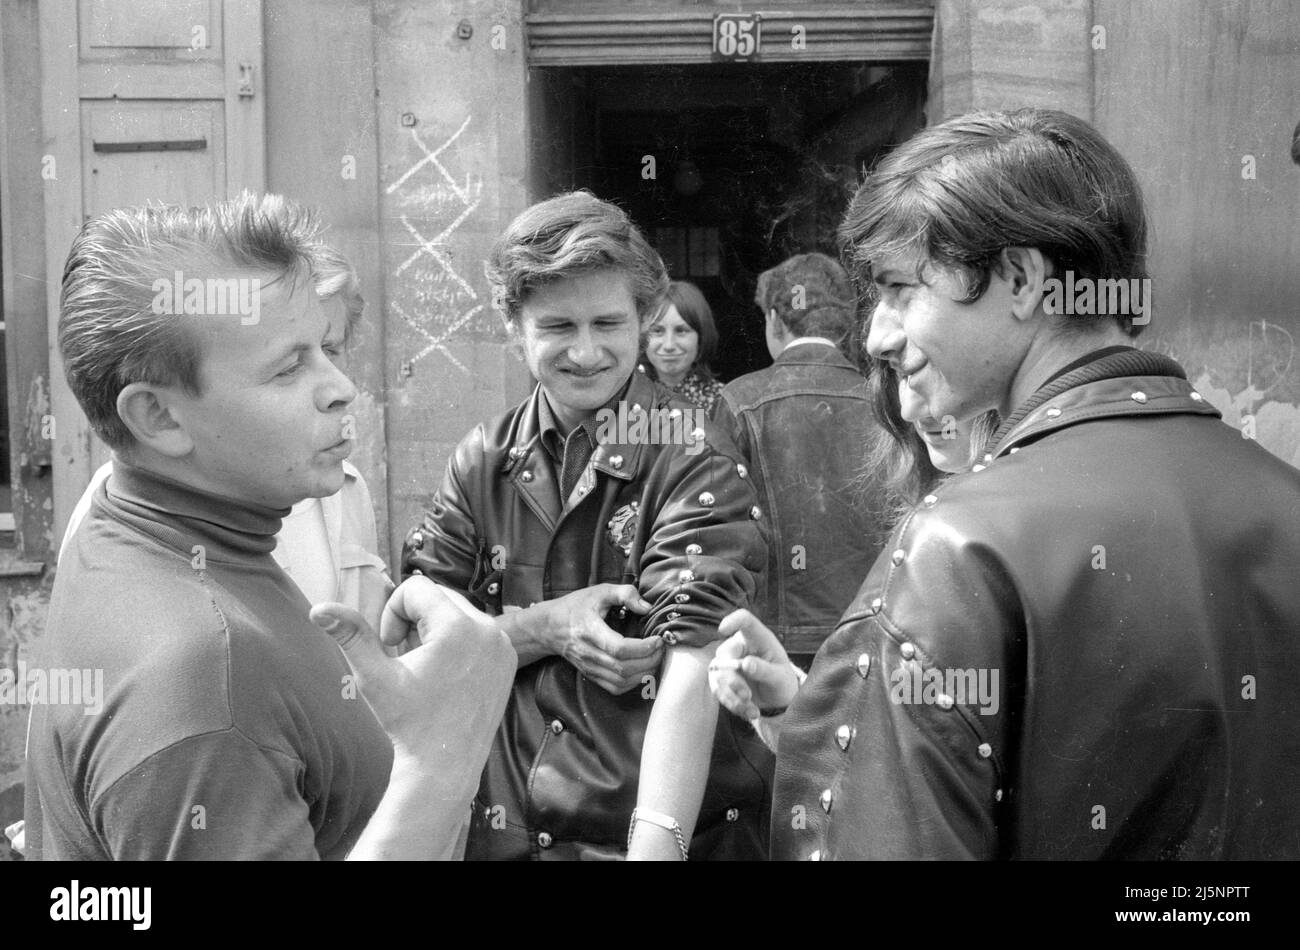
[26,195,515,859]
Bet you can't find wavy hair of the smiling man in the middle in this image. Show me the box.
[488,191,668,326]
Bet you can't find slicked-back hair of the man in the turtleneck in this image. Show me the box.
[59,191,345,450]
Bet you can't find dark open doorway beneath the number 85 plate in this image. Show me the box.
[533,62,927,379]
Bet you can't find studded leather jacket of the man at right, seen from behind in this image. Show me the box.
[772,351,1300,859]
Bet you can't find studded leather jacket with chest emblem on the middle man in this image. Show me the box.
[402,373,774,860]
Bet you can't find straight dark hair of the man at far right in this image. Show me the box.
[840,109,1148,337]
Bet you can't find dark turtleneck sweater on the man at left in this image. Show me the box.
[26,464,393,860]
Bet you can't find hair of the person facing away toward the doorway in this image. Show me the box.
[754,253,857,347]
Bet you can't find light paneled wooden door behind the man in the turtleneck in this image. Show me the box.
[40,0,267,548]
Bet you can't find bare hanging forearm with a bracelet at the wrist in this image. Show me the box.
[628,643,718,860]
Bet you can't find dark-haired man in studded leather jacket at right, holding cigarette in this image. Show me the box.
[715,109,1300,859]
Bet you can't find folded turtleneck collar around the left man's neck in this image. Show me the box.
[96,459,290,561]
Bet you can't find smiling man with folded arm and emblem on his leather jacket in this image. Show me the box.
[402,192,772,859]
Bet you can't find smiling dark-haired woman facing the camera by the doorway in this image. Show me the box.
[641,281,723,413]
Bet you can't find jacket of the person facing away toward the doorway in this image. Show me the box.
[715,343,884,655]
